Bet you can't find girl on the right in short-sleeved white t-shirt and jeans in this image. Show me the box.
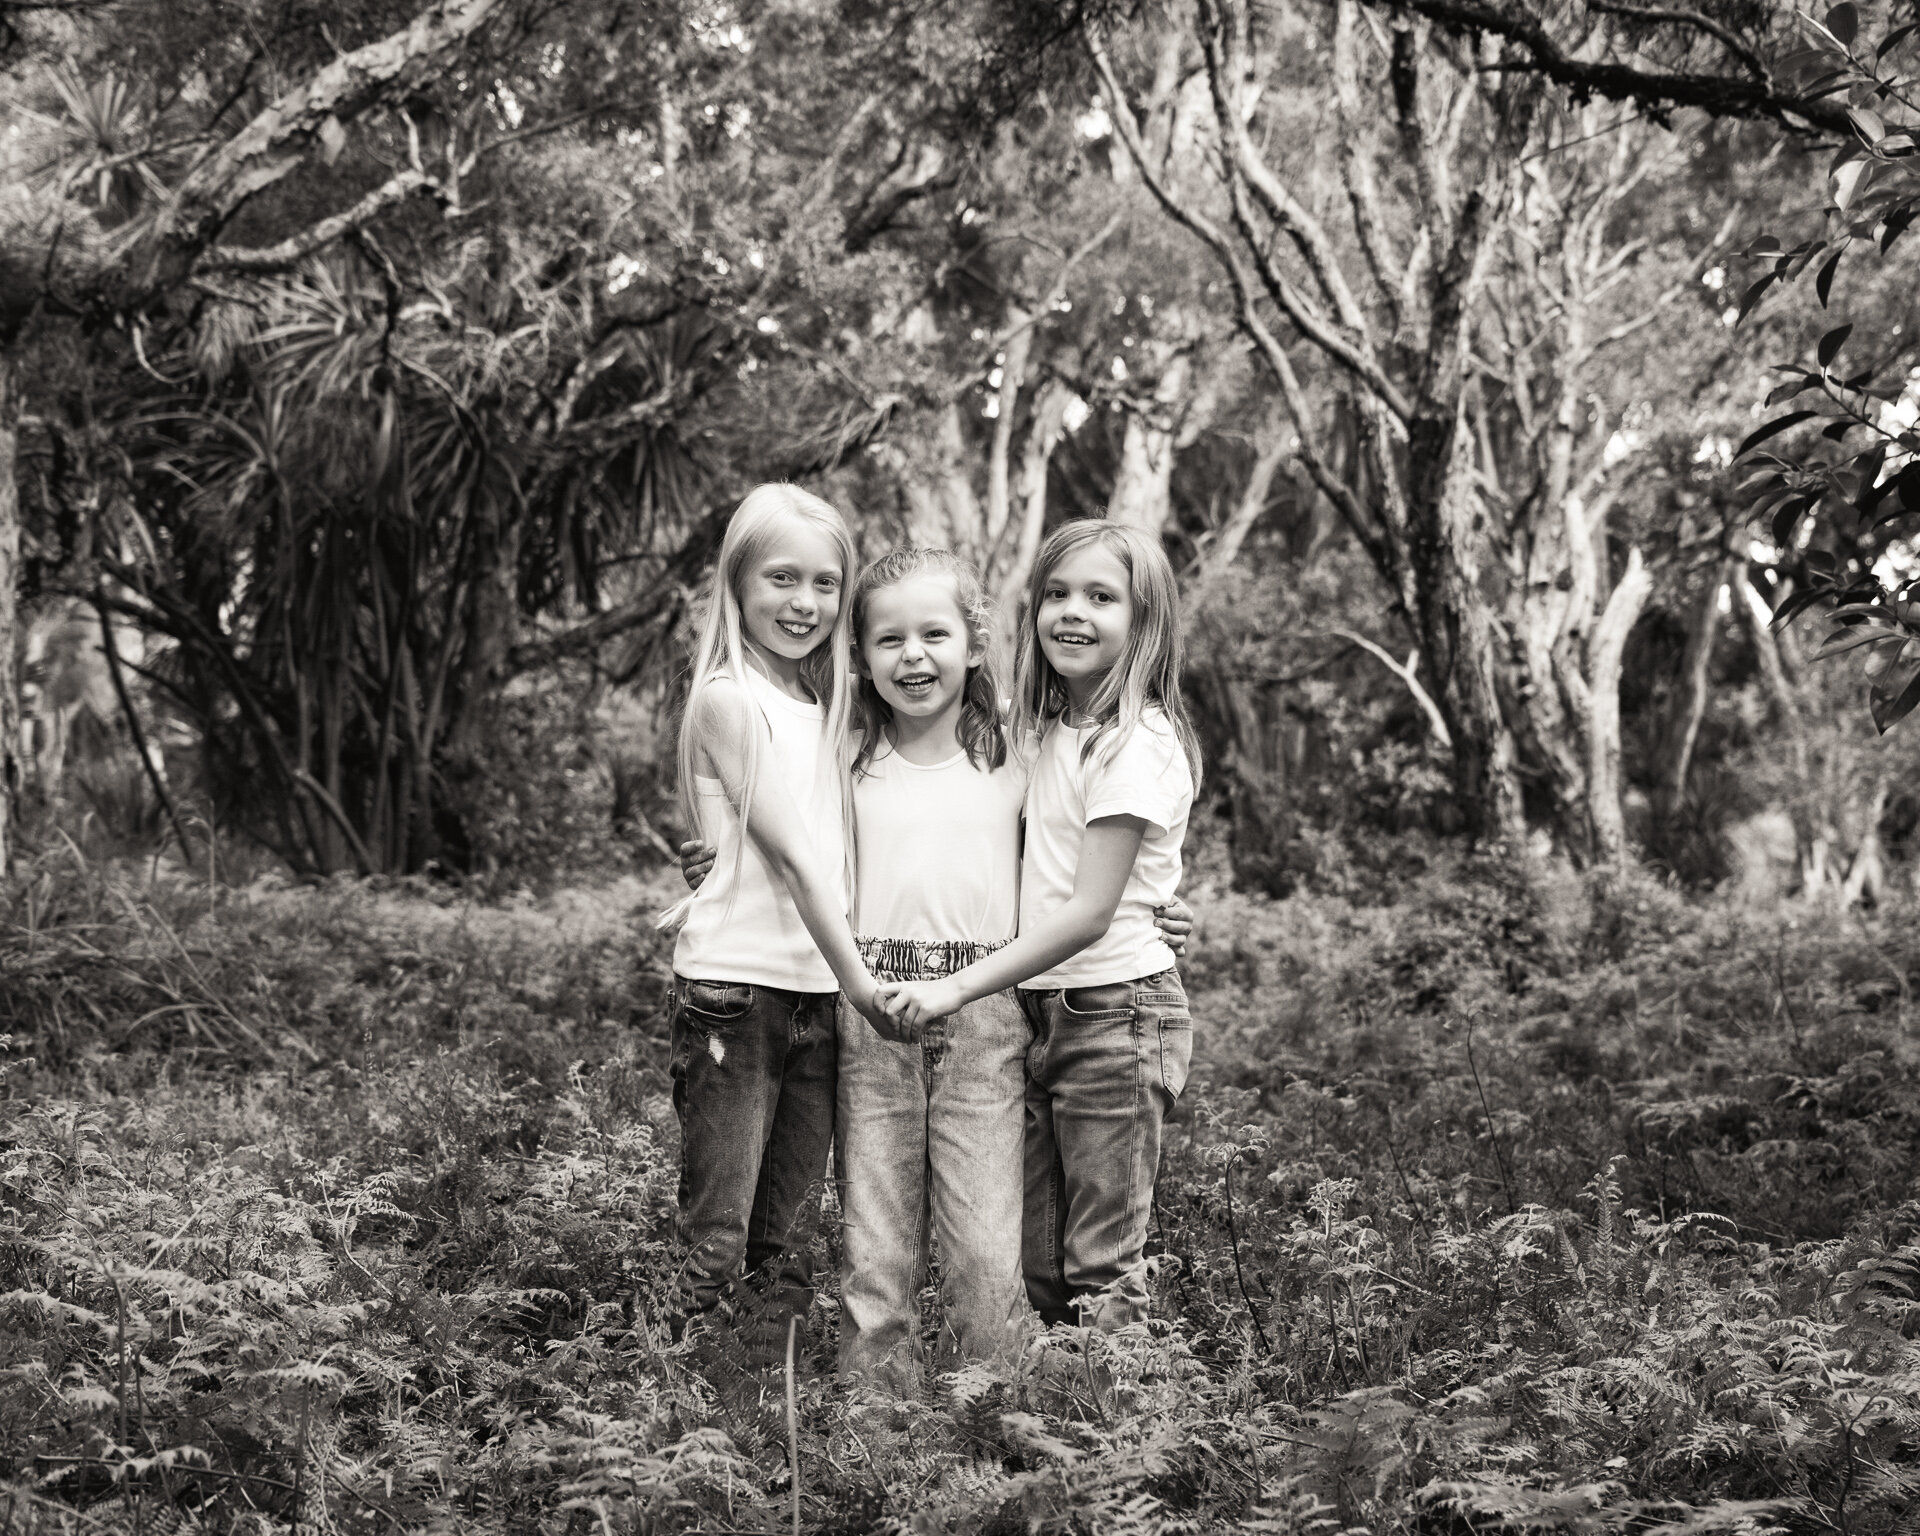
[879,520,1200,1329]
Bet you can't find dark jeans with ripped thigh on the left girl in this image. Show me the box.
[670,975,839,1315]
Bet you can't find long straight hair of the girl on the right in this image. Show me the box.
[1014,516,1200,791]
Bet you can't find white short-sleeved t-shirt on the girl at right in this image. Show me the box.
[1020,708,1194,991]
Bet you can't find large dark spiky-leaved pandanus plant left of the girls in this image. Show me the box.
[108,252,726,874]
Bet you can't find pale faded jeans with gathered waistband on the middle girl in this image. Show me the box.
[837,939,1031,1392]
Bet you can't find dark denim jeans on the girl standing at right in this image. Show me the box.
[1020,970,1194,1329]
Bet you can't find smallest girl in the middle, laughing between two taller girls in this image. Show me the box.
[835,549,1029,1388]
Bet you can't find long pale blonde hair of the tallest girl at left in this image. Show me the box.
[680,482,858,891]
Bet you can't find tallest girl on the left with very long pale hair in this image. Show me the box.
[662,486,885,1338]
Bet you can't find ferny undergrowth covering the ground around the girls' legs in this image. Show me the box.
[0,854,1920,1536]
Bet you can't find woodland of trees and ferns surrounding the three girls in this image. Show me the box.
[0,0,1920,1532]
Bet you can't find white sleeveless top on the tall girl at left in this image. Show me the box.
[674,668,847,993]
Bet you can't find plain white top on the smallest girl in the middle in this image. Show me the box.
[852,747,1027,945]
